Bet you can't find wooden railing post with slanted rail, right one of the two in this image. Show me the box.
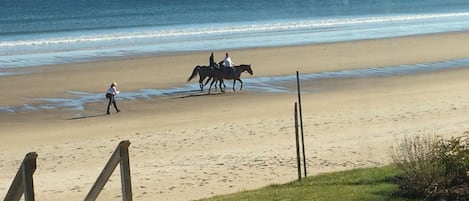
[85,140,132,201]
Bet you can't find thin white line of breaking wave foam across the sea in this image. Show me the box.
[0,12,469,48]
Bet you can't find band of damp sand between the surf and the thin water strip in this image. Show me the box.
[0,32,469,106]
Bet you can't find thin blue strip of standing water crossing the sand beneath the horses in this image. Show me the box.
[0,58,469,114]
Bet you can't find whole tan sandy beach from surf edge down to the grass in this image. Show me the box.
[0,32,469,201]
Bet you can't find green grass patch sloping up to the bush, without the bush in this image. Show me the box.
[196,166,418,201]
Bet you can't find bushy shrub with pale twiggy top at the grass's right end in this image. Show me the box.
[392,132,469,200]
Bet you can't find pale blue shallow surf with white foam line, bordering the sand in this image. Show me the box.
[0,12,469,68]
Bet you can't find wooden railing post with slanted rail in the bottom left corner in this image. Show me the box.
[5,152,37,201]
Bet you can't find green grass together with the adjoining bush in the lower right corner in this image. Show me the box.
[198,132,469,201]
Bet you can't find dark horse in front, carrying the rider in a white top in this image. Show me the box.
[208,64,253,93]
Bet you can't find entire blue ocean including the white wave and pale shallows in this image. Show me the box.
[0,0,469,68]
